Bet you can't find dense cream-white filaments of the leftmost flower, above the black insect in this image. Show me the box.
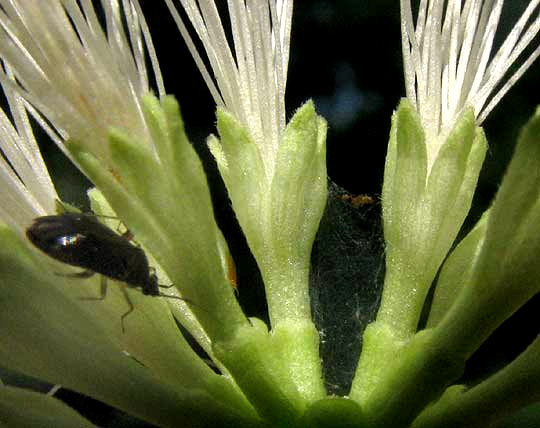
[0,0,164,159]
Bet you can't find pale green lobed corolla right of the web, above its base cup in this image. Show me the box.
[377,100,487,337]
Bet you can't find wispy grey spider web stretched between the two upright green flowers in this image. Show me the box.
[310,182,384,395]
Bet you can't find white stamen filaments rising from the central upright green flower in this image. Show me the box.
[165,0,293,177]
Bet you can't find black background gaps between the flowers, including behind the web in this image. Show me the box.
[11,0,540,427]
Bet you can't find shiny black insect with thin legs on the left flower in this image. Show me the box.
[26,213,185,331]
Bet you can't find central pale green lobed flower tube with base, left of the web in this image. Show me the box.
[208,102,326,400]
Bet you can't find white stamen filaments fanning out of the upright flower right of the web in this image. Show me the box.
[401,0,540,144]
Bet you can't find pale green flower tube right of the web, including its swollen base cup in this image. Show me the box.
[350,100,486,420]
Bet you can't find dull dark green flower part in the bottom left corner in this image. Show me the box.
[0,384,97,428]
